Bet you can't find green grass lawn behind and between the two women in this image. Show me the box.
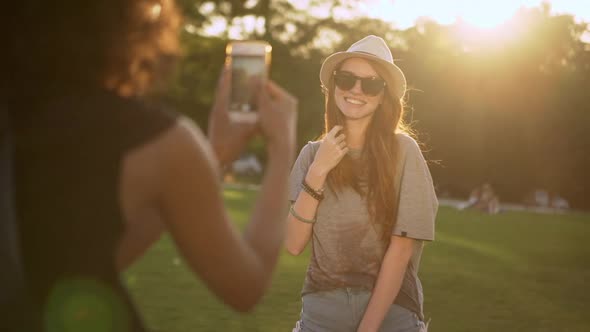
[125,190,590,332]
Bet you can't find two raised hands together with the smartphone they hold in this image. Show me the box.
[208,41,297,165]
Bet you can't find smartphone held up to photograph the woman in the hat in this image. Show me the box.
[225,40,272,121]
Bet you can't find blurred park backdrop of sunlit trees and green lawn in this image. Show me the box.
[126,0,590,332]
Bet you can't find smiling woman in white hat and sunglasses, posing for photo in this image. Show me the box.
[286,36,438,332]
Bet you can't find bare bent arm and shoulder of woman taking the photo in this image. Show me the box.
[117,78,297,311]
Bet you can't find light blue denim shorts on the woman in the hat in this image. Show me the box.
[293,288,427,332]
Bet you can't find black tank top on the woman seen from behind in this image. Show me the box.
[15,91,176,331]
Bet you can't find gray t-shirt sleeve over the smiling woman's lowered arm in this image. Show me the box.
[392,137,438,241]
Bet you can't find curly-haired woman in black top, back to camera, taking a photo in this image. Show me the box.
[0,0,297,332]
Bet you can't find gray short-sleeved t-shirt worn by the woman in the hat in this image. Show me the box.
[289,134,438,319]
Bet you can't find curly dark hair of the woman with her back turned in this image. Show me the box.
[0,0,180,102]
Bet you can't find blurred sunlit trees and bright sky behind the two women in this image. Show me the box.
[157,0,590,210]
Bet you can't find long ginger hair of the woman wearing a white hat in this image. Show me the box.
[323,60,409,242]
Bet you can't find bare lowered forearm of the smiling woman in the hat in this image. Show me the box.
[358,235,416,332]
